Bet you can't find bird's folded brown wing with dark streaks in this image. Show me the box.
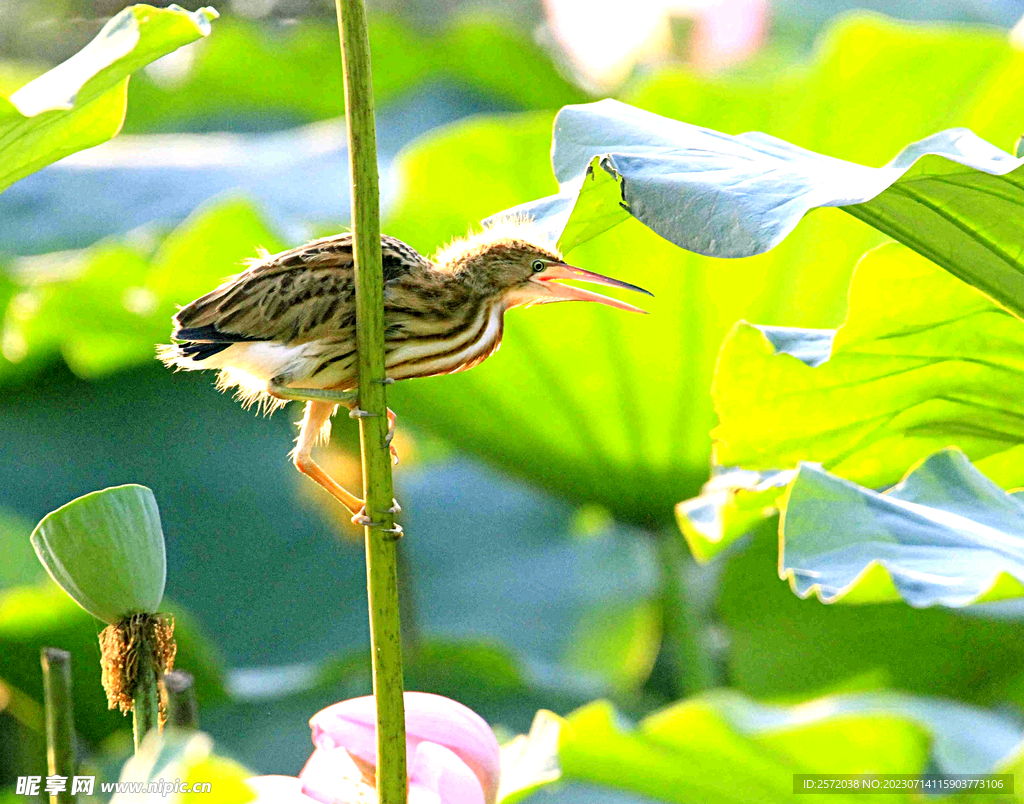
[173,232,429,343]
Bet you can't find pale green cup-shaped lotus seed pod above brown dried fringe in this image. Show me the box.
[31,485,167,625]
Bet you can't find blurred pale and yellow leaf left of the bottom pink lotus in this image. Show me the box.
[111,729,256,804]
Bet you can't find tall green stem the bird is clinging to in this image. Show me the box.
[335,0,408,804]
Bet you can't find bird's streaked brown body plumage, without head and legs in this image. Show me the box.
[155,232,544,408]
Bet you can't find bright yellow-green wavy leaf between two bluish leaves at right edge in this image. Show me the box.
[712,244,1024,488]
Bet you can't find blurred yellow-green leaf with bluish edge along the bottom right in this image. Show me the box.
[512,690,1021,803]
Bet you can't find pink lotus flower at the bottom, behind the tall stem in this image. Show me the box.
[249,692,501,804]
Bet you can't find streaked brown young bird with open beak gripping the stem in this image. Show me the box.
[157,218,653,524]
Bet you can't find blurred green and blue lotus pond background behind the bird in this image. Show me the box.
[6,0,1024,800]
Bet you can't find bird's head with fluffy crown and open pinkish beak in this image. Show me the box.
[434,220,651,312]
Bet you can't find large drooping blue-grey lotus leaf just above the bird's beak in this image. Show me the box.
[508,94,1024,316]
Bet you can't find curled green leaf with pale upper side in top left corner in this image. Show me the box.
[0,5,217,191]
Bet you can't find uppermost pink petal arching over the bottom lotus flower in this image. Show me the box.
[309,692,501,804]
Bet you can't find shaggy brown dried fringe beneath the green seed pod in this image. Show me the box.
[99,613,177,723]
